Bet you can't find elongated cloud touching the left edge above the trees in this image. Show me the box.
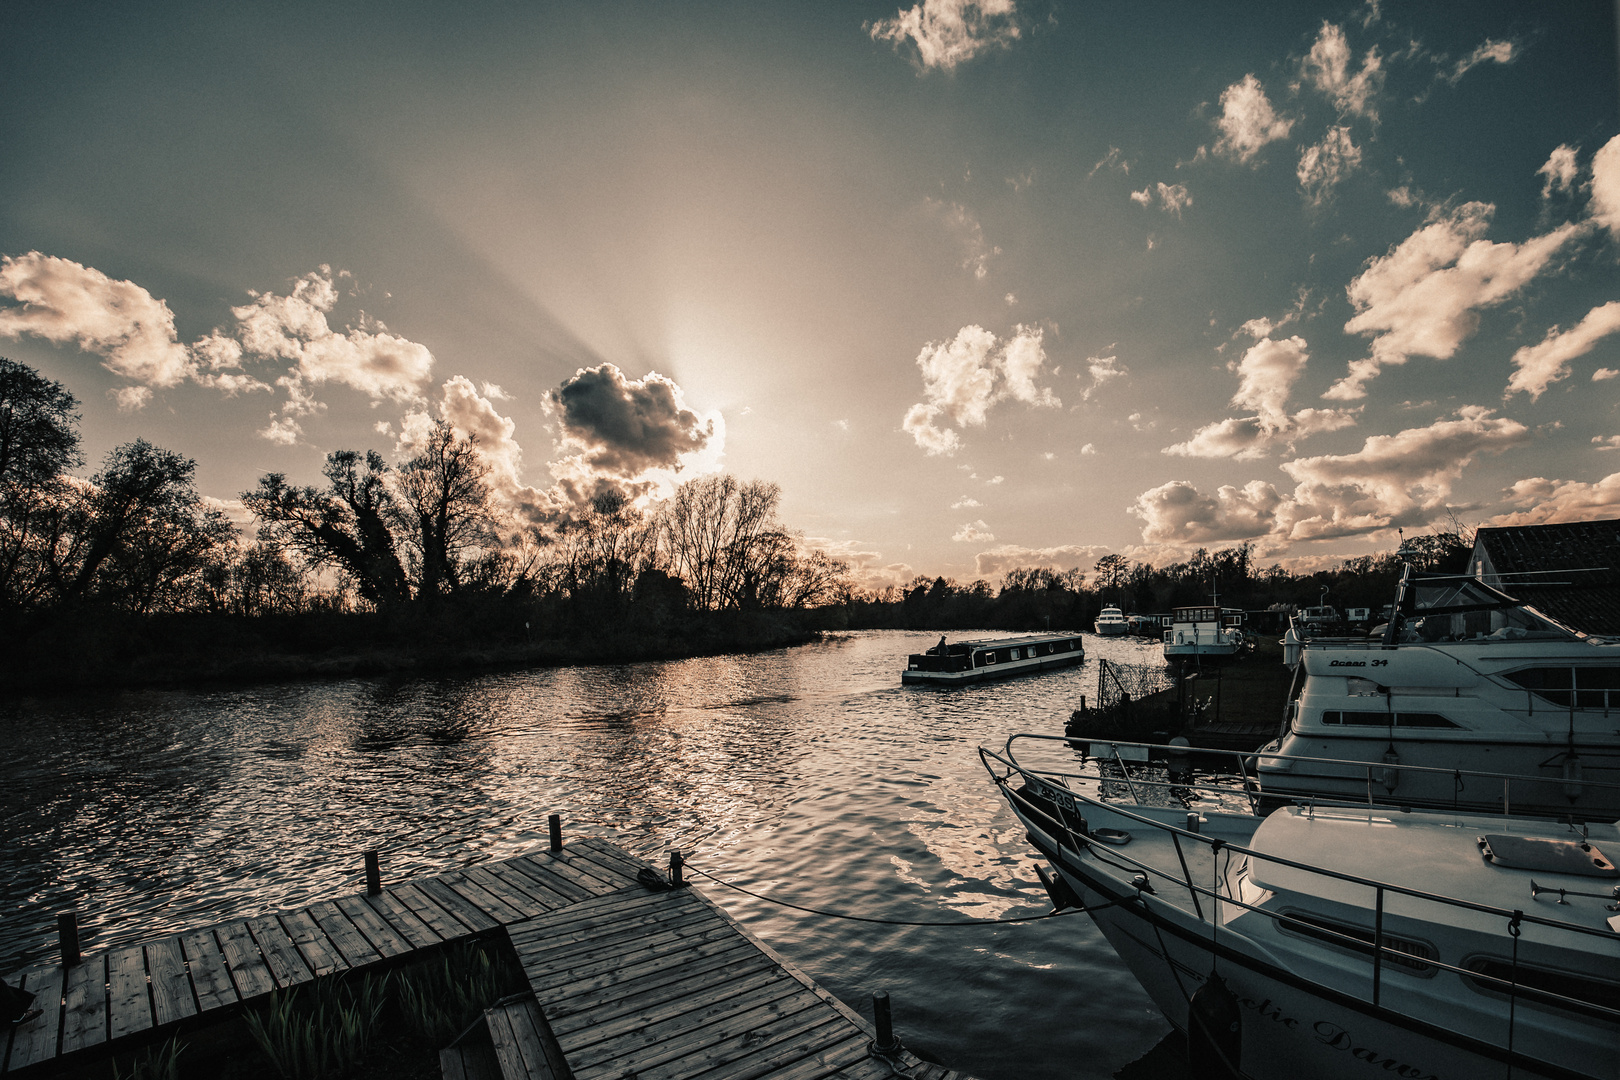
[0,251,252,396]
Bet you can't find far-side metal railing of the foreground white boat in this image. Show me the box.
[1030,733,1620,818]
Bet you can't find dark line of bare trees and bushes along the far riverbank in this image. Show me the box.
[0,358,1468,691]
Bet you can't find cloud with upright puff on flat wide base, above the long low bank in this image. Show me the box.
[1163,335,1356,461]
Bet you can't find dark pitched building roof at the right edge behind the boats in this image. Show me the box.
[1471,518,1620,636]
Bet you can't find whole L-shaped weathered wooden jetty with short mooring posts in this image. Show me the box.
[0,831,970,1080]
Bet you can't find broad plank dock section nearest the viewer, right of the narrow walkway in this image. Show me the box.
[505,880,959,1080]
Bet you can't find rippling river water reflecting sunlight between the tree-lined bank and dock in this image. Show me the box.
[0,631,1170,1080]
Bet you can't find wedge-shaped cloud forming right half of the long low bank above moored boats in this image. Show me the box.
[1280,406,1529,541]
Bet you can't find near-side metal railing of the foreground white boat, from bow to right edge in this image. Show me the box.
[978,735,1620,1048]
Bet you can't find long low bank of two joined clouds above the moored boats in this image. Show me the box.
[1131,406,1529,549]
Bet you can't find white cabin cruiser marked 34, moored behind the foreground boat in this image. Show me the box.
[1257,568,1620,819]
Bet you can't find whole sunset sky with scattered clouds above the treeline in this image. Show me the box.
[0,0,1620,588]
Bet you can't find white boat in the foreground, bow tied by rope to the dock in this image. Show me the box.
[980,735,1620,1080]
